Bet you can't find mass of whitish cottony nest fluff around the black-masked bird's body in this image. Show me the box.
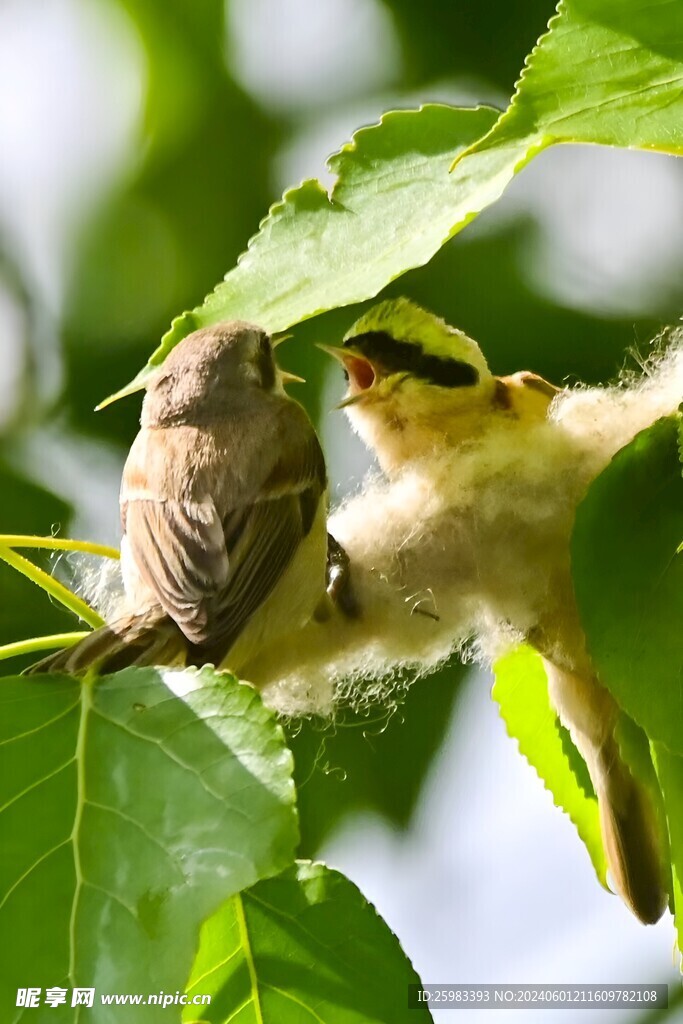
[245,331,683,715]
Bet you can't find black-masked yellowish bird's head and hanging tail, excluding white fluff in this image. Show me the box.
[329,299,668,923]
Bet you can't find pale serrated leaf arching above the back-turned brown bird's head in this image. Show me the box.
[103,103,498,404]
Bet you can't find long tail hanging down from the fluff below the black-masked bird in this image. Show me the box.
[544,659,669,925]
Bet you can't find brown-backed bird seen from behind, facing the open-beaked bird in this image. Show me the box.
[30,321,327,673]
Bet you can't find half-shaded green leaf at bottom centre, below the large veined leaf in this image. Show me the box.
[183,861,431,1024]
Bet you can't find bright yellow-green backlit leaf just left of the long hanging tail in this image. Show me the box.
[493,647,607,887]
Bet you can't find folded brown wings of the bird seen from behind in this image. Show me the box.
[122,420,326,653]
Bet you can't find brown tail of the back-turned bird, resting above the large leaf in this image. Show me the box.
[25,615,187,676]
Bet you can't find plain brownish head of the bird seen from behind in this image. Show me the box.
[142,321,301,425]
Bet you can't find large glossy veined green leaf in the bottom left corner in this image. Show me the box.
[0,669,298,1024]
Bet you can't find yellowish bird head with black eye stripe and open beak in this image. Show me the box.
[322,298,496,469]
